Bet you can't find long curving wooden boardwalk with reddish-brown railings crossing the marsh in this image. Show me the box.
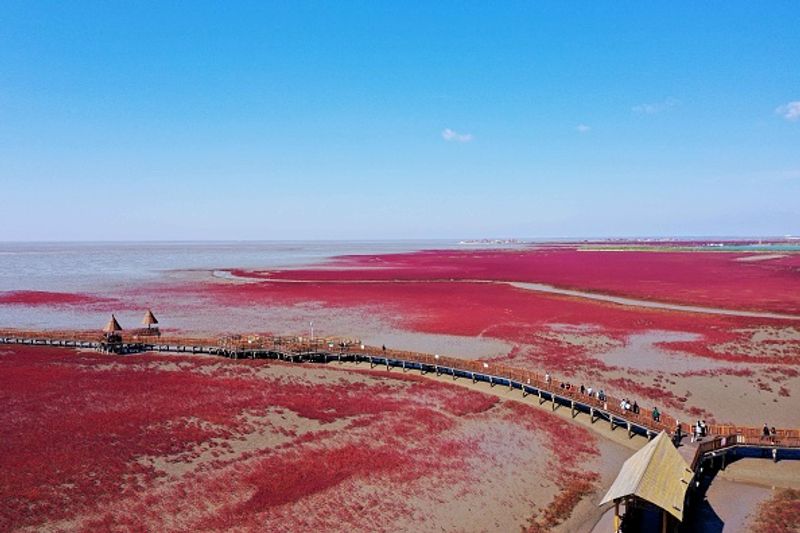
[0,330,800,447]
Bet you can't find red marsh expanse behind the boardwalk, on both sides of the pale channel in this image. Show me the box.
[185,249,800,419]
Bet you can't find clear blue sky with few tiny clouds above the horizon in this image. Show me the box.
[0,0,800,240]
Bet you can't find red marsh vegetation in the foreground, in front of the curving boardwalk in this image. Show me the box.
[0,347,598,531]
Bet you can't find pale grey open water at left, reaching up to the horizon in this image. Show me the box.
[0,241,459,292]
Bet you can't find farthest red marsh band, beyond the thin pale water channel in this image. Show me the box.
[228,247,800,314]
